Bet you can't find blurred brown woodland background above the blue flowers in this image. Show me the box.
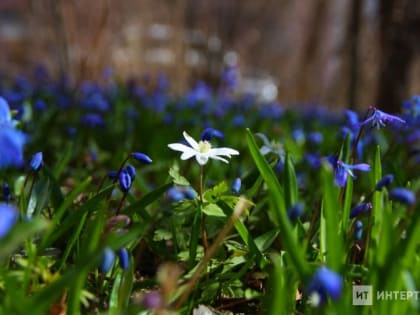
[0,0,420,112]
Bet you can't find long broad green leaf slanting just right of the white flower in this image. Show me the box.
[246,129,309,279]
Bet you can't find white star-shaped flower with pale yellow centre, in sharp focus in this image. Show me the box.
[168,131,239,165]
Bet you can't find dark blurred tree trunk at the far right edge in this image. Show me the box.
[377,0,420,112]
